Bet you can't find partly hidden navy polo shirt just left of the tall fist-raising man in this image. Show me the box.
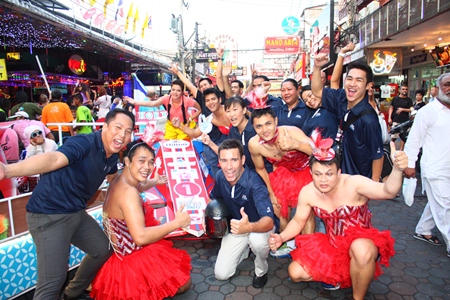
[302,107,339,140]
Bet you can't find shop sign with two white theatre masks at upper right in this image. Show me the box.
[367,48,402,76]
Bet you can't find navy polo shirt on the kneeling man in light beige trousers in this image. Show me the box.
[210,168,279,228]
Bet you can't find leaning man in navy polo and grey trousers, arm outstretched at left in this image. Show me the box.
[0,109,134,300]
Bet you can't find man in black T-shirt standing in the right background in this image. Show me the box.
[388,84,413,150]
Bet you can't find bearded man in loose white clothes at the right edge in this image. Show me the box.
[404,73,450,257]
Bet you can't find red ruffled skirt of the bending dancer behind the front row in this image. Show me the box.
[269,166,312,218]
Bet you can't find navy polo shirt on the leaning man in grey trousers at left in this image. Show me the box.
[26,131,119,214]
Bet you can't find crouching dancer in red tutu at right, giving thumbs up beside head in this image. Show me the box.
[269,140,408,299]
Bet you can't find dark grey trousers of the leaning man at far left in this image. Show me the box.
[27,210,113,300]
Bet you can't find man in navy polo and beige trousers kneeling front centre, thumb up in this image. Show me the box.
[210,139,279,289]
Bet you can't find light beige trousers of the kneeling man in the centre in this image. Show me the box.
[214,227,275,280]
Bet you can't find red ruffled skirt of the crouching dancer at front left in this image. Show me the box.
[91,240,191,300]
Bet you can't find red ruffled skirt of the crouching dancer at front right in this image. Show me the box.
[290,226,395,288]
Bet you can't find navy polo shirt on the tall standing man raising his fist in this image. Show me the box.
[322,88,383,178]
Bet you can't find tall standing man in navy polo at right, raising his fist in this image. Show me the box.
[311,54,384,181]
